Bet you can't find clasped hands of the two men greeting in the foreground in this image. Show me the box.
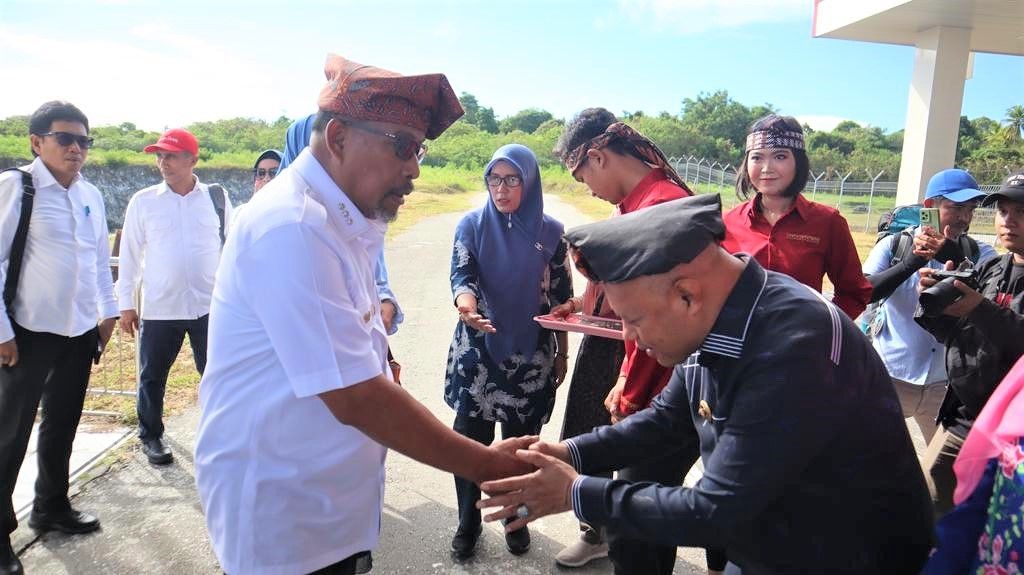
[476,435,579,532]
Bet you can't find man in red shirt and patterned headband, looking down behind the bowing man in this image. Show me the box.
[552,107,704,575]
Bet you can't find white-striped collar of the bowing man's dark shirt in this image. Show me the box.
[700,255,768,359]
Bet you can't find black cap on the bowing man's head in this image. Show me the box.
[565,193,725,283]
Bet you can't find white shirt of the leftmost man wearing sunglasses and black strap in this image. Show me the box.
[0,158,118,342]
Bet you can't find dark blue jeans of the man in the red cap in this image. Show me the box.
[136,314,210,441]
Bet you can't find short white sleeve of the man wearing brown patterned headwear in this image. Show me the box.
[238,224,383,397]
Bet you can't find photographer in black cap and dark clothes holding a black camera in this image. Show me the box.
[916,172,1024,516]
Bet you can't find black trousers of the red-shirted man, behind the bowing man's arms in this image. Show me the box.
[607,451,693,575]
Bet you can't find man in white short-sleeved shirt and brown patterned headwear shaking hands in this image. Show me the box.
[196,55,528,575]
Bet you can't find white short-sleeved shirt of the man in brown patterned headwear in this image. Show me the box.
[196,149,390,574]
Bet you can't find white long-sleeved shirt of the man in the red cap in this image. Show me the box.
[117,178,231,319]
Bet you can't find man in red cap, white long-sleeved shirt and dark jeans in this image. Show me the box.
[117,128,231,466]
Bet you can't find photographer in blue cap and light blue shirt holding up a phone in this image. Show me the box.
[863,170,996,448]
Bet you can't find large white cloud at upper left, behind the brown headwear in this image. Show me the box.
[0,24,309,131]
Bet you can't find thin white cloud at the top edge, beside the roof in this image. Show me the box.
[618,0,813,34]
